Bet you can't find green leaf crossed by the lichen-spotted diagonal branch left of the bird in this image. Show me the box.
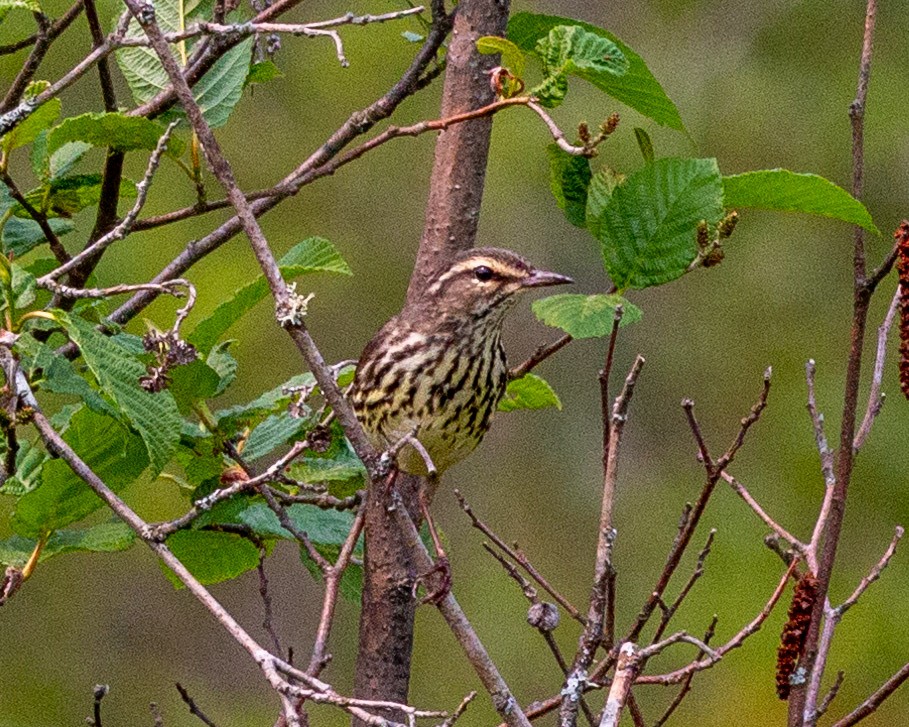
[187,237,351,352]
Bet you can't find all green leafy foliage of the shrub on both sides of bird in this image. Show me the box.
[0,8,892,724]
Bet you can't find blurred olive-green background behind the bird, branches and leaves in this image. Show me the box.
[0,0,909,727]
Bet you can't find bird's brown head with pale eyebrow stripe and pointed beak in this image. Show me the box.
[421,247,574,321]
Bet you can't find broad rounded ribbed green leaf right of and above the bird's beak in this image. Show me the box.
[595,158,724,290]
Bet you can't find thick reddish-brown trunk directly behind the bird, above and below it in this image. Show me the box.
[354,0,508,716]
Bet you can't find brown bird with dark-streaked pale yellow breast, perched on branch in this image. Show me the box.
[351,248,573,474]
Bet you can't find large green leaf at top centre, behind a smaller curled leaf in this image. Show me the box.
[508,13,685,131]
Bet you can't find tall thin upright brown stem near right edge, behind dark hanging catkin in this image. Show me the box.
[789,0,877,727]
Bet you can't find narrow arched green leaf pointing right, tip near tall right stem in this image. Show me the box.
[723,169,881,235]
